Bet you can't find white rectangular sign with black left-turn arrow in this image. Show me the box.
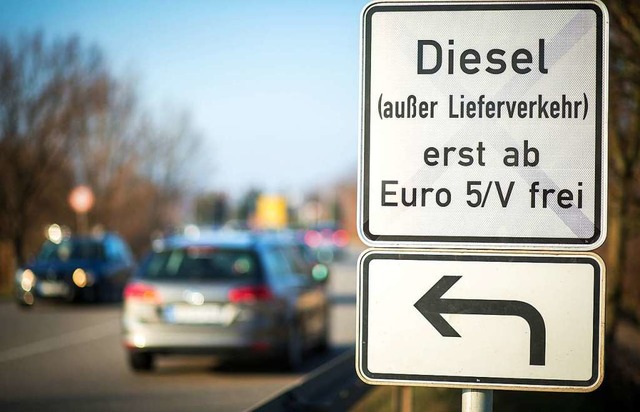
[356,249,604,392]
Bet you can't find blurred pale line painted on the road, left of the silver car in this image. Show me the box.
[0,319,120,363]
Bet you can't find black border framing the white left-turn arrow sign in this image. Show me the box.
[357,251,603,392]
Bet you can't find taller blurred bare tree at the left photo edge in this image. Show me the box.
[0,34,107,262]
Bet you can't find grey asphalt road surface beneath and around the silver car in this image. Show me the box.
[0,249,356,412]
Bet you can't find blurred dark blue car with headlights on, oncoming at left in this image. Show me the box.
[15,233,135,306]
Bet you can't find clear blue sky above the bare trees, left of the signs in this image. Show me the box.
[0,0,367,198]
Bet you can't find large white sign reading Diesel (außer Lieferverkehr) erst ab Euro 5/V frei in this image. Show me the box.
[358,0,609,251]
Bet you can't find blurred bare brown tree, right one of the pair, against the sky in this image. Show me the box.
[74,79,208,252]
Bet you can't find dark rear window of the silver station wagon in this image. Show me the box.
[143,246,259,280]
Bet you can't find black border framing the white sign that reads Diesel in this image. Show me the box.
[358,3,606,249]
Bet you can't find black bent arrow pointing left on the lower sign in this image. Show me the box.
[414,276,547,366]
